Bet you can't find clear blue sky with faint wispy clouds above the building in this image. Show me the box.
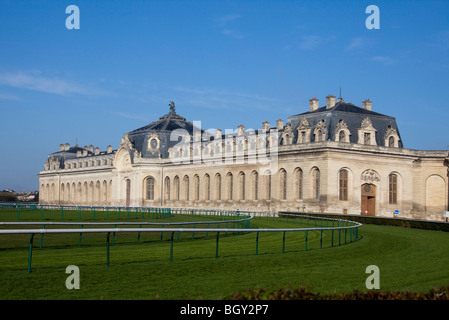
[0,0,449,191]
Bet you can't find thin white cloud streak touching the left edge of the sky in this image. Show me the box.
[0,71,104,95]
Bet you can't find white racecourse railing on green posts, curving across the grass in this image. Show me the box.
[0,205,362,272]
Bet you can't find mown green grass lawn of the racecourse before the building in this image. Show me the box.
[0,210,449,300]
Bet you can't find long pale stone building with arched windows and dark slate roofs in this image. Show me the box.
[39,95,449,220]
